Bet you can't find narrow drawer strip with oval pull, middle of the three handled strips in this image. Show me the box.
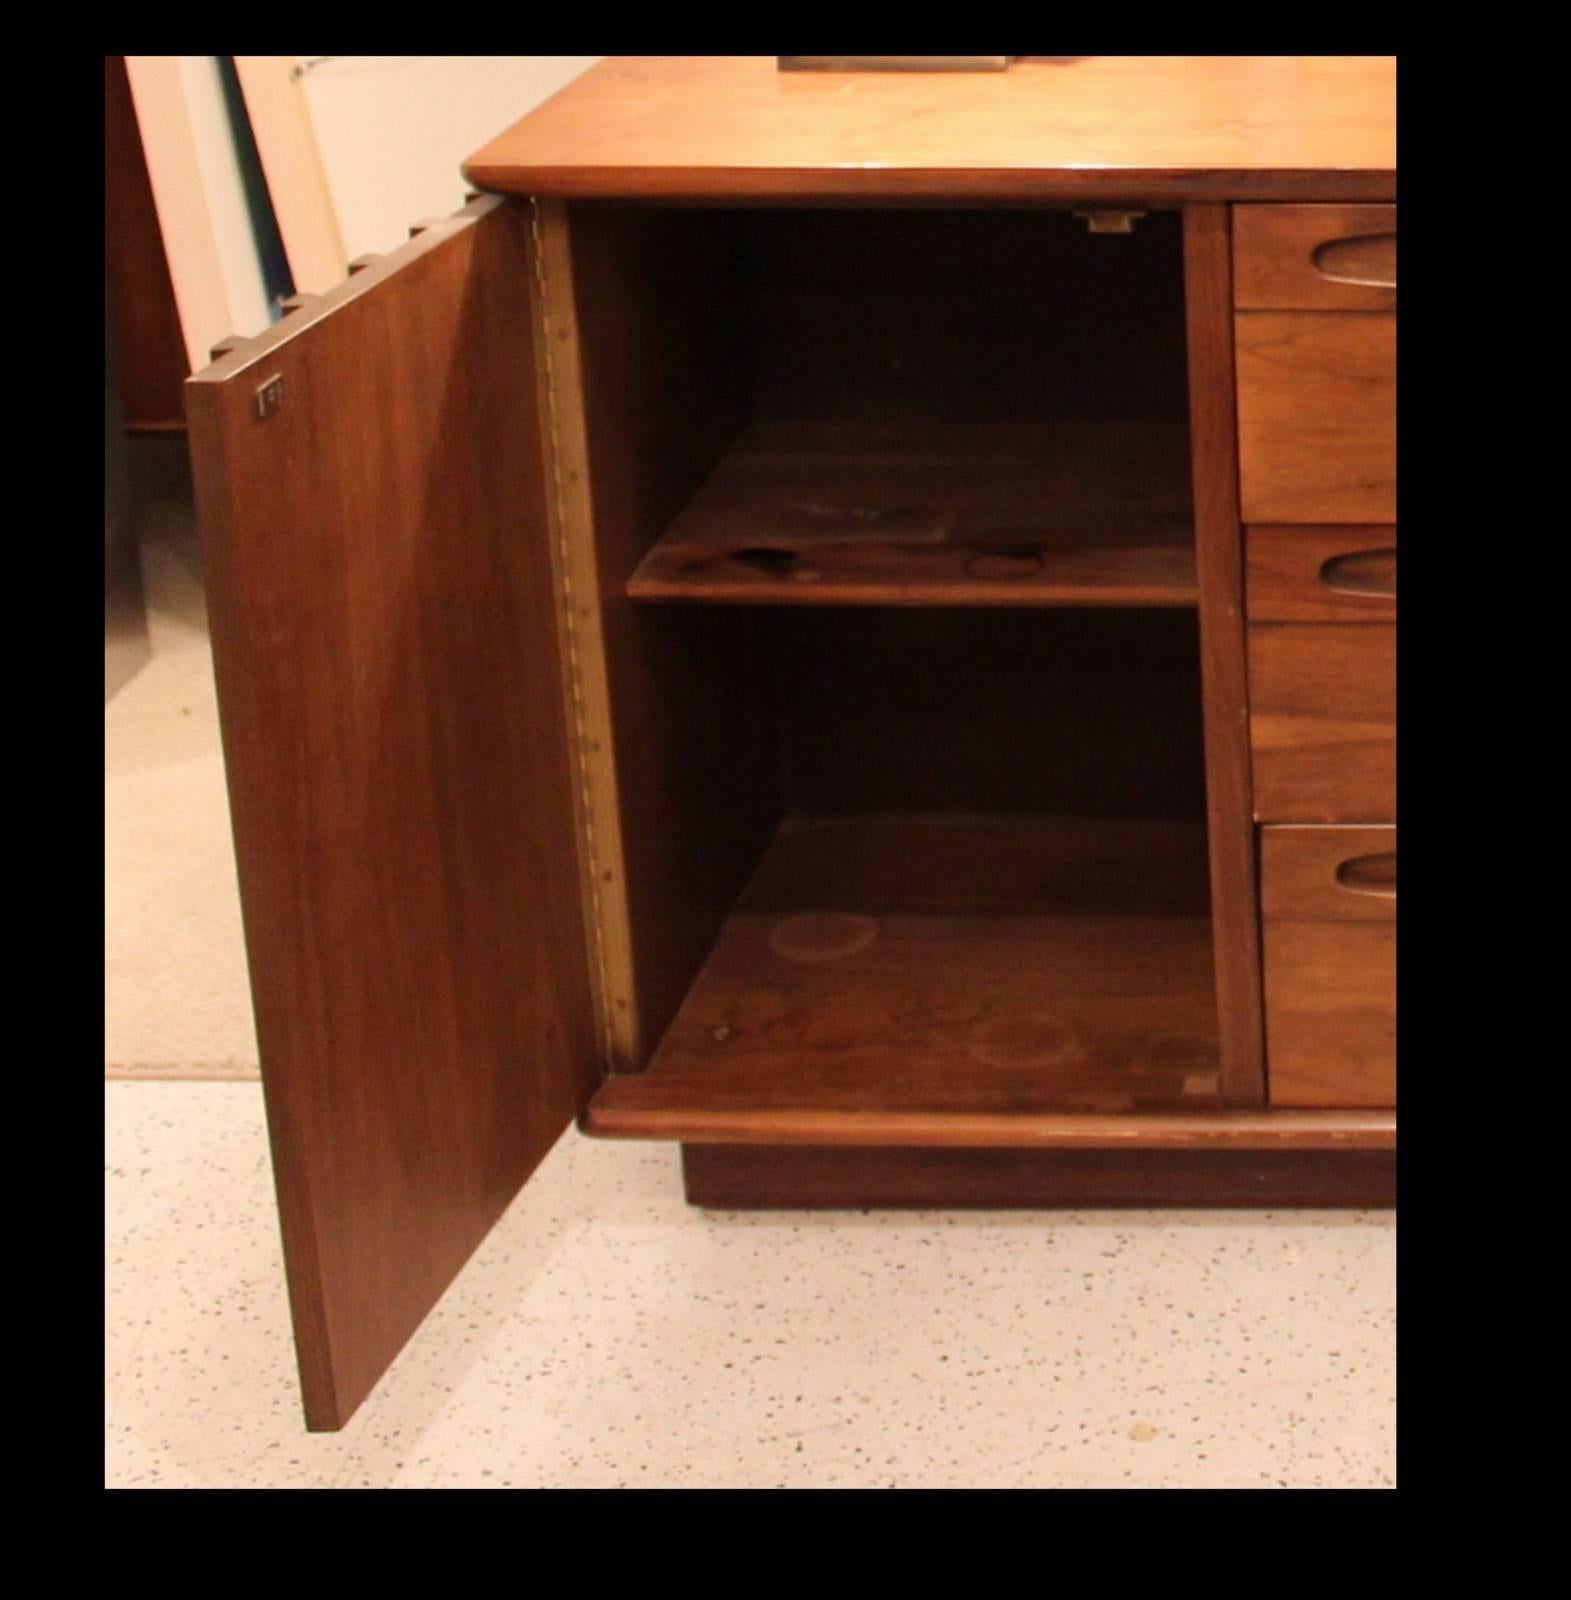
[1245,526,1397,622]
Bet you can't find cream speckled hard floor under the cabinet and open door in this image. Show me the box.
[106,1083,1395,1488]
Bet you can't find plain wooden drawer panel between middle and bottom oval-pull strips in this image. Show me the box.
[1249,622,1397,822]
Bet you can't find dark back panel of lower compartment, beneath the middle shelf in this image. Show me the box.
[768,608,1205,821]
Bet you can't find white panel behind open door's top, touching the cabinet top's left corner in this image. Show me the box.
[299,56,602,256]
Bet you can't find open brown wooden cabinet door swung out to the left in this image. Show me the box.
[187,197,598,1429]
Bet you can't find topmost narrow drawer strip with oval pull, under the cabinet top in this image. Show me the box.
[1233,205,1397,310]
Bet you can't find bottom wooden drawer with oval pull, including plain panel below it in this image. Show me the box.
[1261,827,1397,1109]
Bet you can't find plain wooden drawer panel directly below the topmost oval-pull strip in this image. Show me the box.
[1233,310,1397,523]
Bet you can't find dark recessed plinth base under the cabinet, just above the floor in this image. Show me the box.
[682,1144,1397,1211]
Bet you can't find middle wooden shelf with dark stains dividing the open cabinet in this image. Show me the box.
[627,419,1197,606]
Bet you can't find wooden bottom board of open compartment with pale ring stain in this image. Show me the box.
[584,818,1286,1146]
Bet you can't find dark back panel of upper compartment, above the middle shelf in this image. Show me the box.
[738,210,1187,422]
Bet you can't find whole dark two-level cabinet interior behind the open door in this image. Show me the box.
[570,203,1219,1138]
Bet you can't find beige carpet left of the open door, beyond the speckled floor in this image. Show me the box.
[104,507,258,1078]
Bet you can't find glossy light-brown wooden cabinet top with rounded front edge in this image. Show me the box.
[464,56,1397,202]
